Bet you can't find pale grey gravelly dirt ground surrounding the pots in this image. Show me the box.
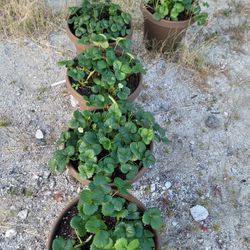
[0,0,250,250]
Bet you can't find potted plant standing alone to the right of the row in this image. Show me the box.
[141,0,208,49]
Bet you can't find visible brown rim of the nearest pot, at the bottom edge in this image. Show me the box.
[46,194,161,250]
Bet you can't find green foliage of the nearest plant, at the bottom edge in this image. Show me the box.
[52,184,162,250]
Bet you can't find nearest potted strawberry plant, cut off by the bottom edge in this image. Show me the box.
[46,176,163,250]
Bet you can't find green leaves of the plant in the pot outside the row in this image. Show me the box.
[144,0,208,25]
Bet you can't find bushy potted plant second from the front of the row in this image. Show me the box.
[49,100,167,187]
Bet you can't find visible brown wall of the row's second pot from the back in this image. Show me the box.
[66,74,143,111]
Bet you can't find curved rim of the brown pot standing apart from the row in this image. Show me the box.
[140,3,193,27]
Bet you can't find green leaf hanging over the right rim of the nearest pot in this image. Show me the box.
[142,208,163,230]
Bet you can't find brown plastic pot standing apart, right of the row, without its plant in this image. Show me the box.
[141,4,192,50]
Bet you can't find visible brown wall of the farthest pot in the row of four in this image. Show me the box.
[66,22,133,54]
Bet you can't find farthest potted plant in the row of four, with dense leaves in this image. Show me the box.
[67,0,132,53]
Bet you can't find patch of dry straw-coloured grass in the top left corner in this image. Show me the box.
[0,0,64,39]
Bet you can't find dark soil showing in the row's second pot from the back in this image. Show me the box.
[69,74,140,97]
